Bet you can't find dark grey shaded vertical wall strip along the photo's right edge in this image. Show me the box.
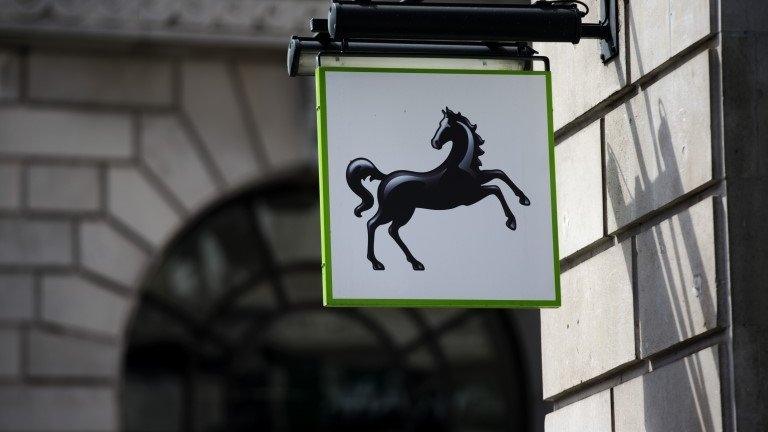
[721,1,768,431]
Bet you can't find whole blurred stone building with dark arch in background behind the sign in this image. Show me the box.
[0,0,545,432]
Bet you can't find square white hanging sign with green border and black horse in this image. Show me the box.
[316,67,560,307]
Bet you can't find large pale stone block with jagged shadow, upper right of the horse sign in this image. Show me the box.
[605,52,713,233]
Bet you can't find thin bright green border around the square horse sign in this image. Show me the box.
[315,66,561,308]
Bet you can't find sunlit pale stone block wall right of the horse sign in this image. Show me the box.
[535,0,728,432]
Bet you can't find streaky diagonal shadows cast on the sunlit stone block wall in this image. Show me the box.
[604,22,721,431]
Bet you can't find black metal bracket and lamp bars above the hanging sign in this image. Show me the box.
[288,0,618,76]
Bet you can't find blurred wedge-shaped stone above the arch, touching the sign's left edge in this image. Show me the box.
[239,61,317,167]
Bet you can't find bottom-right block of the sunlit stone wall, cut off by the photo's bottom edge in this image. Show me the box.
[613,347,720,432]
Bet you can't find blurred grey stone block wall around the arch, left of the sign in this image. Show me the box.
[0,46,314,431]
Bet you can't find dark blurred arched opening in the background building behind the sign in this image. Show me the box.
[122,170,539,432]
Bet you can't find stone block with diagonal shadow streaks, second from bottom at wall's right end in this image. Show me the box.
[636,198,717,357]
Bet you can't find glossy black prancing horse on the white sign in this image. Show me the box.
[347,107,531,270]
